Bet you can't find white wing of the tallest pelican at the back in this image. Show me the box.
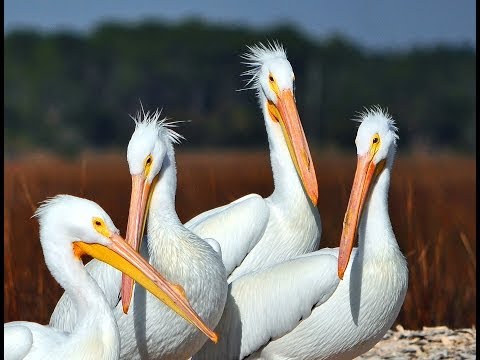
[185,194,270,275]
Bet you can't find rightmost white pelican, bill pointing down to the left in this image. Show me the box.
[194,108,408,360]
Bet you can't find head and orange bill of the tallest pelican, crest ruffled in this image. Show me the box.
[242,42,318,205]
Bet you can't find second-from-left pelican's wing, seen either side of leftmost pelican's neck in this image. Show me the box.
[49,259,122,332]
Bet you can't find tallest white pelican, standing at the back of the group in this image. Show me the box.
[185,43,321,283]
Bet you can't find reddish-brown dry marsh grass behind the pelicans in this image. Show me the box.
[3,152,476,328]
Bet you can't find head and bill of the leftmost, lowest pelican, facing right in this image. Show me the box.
[34,195,217,339]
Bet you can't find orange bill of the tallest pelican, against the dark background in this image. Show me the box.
[277,90,318,206]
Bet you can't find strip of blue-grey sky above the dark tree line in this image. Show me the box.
[4,0,476,49]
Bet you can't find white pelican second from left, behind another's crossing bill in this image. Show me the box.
[50,111,227,359]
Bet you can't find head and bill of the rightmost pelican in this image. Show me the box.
[338,107,398,279]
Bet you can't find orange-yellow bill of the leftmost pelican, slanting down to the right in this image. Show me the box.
[74,234,218,343]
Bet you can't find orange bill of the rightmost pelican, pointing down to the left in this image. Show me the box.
[338,152,384,279]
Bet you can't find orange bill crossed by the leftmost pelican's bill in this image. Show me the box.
[121,175,150,314]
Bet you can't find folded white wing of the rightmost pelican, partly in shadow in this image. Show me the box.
[194,251,340,359]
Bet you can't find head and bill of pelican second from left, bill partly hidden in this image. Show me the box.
[122,107,183,313]
